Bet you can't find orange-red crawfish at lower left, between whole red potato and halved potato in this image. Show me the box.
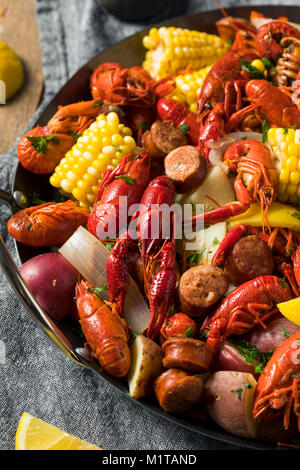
[76,281,130,377]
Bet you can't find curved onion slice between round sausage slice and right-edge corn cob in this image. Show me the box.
[207,132,262,174]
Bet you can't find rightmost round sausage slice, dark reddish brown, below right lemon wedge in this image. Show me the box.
[225,235,274,286]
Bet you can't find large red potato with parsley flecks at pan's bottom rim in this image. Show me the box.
[204,370,257,438]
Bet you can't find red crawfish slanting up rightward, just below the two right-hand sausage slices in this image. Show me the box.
[201,276,291,350]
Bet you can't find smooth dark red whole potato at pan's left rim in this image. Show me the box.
[20,253,78,321]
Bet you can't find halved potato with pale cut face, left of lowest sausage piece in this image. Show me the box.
[128,335,163,400]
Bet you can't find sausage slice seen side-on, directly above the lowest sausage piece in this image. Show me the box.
[162,337,213,373]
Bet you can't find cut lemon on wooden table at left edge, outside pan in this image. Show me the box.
[0,41,24,99]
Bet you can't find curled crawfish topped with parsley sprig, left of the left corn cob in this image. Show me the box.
[18,101,100,174]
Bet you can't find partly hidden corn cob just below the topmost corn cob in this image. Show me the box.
[168,65,212,113]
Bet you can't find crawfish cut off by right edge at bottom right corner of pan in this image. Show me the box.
[253,331,300,431]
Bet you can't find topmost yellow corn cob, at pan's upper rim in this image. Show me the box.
[143,27,230,80]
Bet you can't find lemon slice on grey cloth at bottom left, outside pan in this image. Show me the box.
[15,413,102,450]
